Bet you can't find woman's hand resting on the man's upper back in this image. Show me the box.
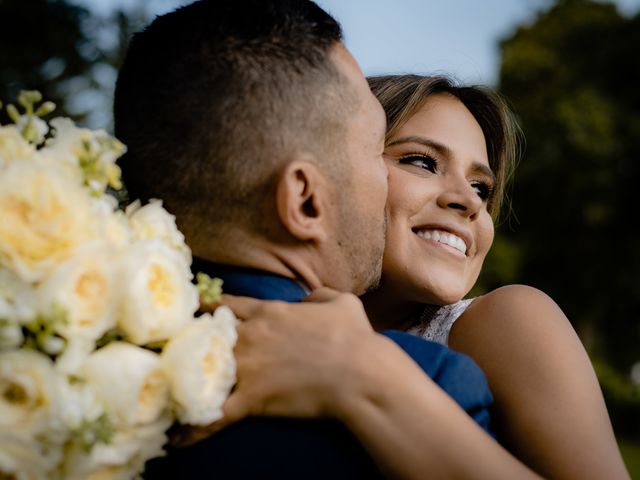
[173,288,386,446]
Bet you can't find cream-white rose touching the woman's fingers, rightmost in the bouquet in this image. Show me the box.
[162,307,238,425]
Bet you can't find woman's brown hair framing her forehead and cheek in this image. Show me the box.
[367,74,523,221]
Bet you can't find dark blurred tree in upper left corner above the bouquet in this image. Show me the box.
[0,0,149,129]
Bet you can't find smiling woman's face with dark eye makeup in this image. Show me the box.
[382,94,495,305]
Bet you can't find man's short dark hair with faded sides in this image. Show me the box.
[114,0,356,246]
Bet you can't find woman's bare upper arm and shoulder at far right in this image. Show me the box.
[449,285,629,479]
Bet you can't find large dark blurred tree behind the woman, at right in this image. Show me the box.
[482,0,640,436]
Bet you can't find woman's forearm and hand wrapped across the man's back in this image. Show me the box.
[185,290,537,479]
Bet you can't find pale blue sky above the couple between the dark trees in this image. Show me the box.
[73,0,640,84]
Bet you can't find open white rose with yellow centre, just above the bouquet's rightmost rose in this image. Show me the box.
[119,239,199,345]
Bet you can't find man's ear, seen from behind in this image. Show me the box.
[276,159,329,241]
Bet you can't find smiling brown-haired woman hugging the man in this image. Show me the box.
[192,75,628,479]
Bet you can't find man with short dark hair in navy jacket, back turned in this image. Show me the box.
[115,0,490,478]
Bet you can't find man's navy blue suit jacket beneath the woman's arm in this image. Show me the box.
[144,260,492,479]
